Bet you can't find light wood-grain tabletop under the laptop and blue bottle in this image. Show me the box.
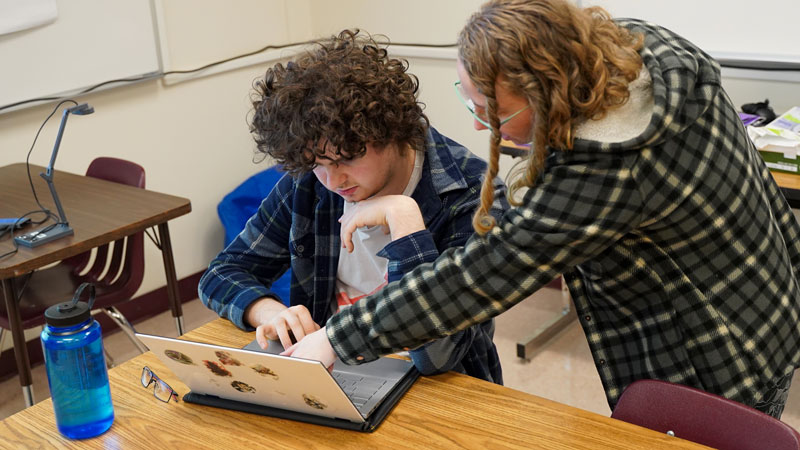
[0,319,707,449]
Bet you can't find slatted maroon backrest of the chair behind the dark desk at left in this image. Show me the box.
[65,157,145,308]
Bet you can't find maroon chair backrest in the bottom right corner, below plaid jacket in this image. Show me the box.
[611,380,800,450]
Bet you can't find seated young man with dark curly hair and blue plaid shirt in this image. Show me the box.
[199,30,508,384]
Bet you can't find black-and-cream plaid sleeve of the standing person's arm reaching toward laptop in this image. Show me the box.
[326,166,642,363]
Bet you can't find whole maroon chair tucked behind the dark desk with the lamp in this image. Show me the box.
[0,157,147,370]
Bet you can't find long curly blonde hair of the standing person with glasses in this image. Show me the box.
[458,0,643,235]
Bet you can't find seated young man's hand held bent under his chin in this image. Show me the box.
[339,195,425,252]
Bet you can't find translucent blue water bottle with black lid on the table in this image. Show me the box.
[42,283,114,439]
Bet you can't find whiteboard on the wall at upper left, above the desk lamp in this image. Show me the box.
[0,0,161,107]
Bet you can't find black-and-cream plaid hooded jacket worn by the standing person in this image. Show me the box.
[327,19,800,409]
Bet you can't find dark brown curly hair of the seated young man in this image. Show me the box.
[250,30,429,176]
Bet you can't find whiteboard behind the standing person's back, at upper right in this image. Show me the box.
[578,0,800,68]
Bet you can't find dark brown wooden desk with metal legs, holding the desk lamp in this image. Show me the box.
[0,163,192,406]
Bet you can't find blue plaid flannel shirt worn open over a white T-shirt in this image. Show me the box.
[198,128,508,384]
